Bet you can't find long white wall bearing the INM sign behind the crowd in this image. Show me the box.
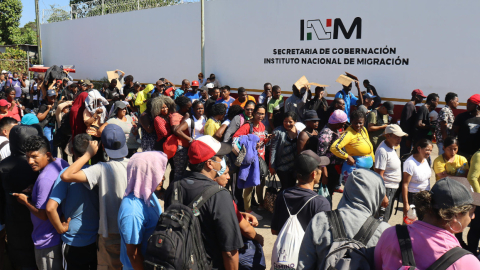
[42,0,480,102]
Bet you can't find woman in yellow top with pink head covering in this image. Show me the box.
[330,110,375,184]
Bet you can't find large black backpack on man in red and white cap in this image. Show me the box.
[143,181,226,270]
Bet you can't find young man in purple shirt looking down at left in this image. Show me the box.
[13,136,68,270]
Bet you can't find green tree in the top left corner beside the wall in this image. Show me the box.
[0,0,23,45]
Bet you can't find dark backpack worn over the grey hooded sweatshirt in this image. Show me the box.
[321,210,381,270]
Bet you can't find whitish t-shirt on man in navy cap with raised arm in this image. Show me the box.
[82,158,128,237]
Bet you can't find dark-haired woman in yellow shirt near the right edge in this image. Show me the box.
[433,137,469,181]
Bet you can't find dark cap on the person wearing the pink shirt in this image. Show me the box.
[430,176,480,209]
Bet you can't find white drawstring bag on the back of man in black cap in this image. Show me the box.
[272,190,318,269]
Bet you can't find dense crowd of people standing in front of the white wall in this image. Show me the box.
[0,70,480,270]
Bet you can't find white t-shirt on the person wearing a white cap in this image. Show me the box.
[375,141,402,188]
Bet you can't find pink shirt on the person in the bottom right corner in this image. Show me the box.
[375,221,480,270]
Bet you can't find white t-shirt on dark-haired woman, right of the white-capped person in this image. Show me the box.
[403,156,432,193]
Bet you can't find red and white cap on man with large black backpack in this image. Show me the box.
[188,135,232,164]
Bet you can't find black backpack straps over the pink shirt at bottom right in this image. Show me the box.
[395,225,472,270]
